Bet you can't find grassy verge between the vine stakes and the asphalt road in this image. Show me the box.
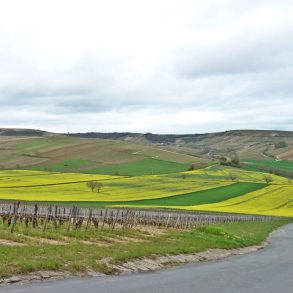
[0,220,289,278]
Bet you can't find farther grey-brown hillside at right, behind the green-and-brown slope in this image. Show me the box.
[70,130,293,160]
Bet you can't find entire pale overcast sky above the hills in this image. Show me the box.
[0,0,293,134]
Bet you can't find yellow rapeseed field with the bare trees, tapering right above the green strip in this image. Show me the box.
[0,171,231,202]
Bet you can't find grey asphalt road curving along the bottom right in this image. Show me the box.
[0,224,293,293]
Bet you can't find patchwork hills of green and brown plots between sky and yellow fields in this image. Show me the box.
[0,128,293,175]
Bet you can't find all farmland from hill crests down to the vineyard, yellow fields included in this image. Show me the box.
[0,130,293,216]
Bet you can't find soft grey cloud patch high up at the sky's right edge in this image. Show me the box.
[178,31,293,78]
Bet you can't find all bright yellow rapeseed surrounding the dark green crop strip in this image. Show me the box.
[0,168,293,216]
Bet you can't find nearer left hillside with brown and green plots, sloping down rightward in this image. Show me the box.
[0,133,206,175]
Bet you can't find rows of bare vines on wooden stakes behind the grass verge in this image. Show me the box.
[0,202,276,232]
